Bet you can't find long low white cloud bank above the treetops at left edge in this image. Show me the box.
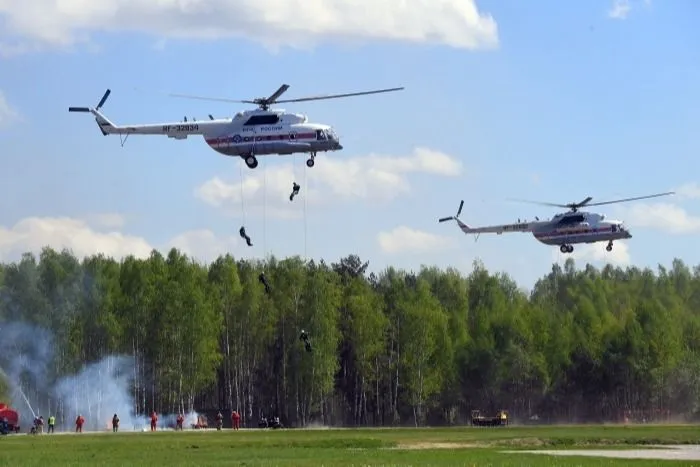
[0,217,238,262]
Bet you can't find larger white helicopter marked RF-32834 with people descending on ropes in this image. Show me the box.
[68,84,404,169]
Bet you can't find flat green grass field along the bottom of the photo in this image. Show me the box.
[0,425,700,467]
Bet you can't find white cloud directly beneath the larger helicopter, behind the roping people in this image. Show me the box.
[195,148,462,218]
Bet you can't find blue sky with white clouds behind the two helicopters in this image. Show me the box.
[0,0,700,288]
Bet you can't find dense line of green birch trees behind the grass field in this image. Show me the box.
[0,248,700,426]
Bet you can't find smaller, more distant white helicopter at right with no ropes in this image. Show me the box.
[438,191,675,253]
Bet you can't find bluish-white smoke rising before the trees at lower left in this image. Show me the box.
[0,322,197,431]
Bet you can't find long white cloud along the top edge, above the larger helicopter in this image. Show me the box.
[0,0,498,52]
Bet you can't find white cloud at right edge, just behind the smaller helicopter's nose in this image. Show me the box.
[624,203,700,235]
